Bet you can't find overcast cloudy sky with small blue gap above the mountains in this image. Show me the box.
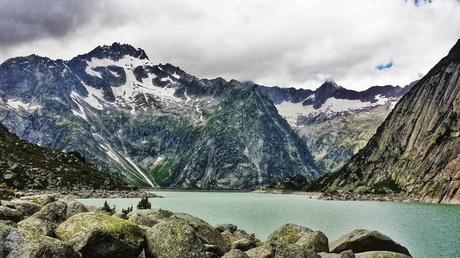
[0,0,460,90]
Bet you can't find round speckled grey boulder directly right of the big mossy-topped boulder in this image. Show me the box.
[145,219,207,258]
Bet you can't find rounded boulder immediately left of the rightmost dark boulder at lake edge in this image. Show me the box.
[267,224,329,253]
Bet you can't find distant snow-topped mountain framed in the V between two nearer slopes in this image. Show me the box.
[252,81,414,173]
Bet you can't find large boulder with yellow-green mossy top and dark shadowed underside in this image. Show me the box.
[56,212,144,258]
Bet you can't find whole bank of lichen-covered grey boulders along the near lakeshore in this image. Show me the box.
[0,195,410,258]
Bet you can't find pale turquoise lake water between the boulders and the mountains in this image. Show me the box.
[77,192,460,258]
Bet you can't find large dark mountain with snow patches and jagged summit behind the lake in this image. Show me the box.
[0,43,319,189]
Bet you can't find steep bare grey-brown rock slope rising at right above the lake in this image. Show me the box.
[312,40,460,204]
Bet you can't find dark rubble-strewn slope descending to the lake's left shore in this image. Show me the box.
[0,124,127,189]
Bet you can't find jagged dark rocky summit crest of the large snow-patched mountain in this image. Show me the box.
[84,42,148,60]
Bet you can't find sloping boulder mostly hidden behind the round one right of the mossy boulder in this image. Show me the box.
[171,213,230,256]
